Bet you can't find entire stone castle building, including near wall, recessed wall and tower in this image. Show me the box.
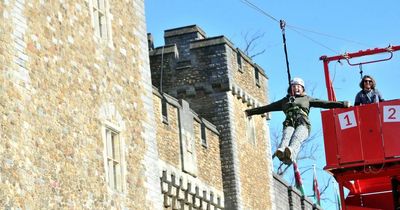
[0,0,322,210]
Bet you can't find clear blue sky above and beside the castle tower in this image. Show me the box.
[145,0,400,209]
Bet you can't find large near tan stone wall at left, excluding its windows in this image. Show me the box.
[0,0,162,209]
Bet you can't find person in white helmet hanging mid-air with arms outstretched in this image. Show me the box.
[245,78,349,165]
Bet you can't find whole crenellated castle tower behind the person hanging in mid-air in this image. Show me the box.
[150,25,273,209]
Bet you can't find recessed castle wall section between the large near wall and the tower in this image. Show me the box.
[153,90,224,209]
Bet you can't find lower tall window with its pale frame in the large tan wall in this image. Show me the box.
[103,122,126,193]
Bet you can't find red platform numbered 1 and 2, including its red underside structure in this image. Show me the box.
[321,99,400,210]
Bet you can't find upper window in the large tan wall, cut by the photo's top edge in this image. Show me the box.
[90,0,111,41]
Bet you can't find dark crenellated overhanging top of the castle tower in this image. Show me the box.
[150,25,268,106]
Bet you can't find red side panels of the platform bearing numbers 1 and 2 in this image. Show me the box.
[321,99,400,170]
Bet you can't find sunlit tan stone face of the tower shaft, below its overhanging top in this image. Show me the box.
[234,98,273,209]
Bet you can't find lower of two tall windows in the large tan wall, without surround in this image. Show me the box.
[105,127,123,192]
